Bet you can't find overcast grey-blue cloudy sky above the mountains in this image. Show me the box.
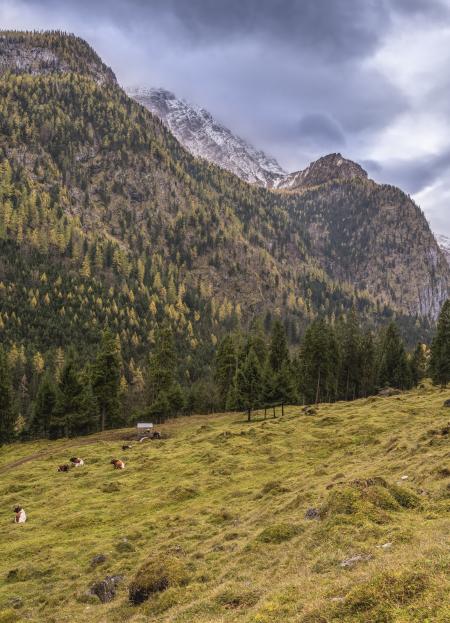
[0,0,450,236]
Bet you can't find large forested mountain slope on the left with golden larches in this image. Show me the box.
[0,33,392,380]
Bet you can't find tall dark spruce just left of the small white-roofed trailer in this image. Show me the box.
[92,329,121,430]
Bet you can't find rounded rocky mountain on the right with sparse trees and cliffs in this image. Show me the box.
[282,161,450,318]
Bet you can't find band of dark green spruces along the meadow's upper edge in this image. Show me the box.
[0,300,450,443]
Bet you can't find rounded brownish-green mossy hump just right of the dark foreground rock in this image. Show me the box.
[129,555,188,605]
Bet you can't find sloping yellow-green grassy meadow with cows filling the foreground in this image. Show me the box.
[0,387,450,623]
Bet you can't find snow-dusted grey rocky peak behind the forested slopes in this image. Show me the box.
[128,88,286,186]
